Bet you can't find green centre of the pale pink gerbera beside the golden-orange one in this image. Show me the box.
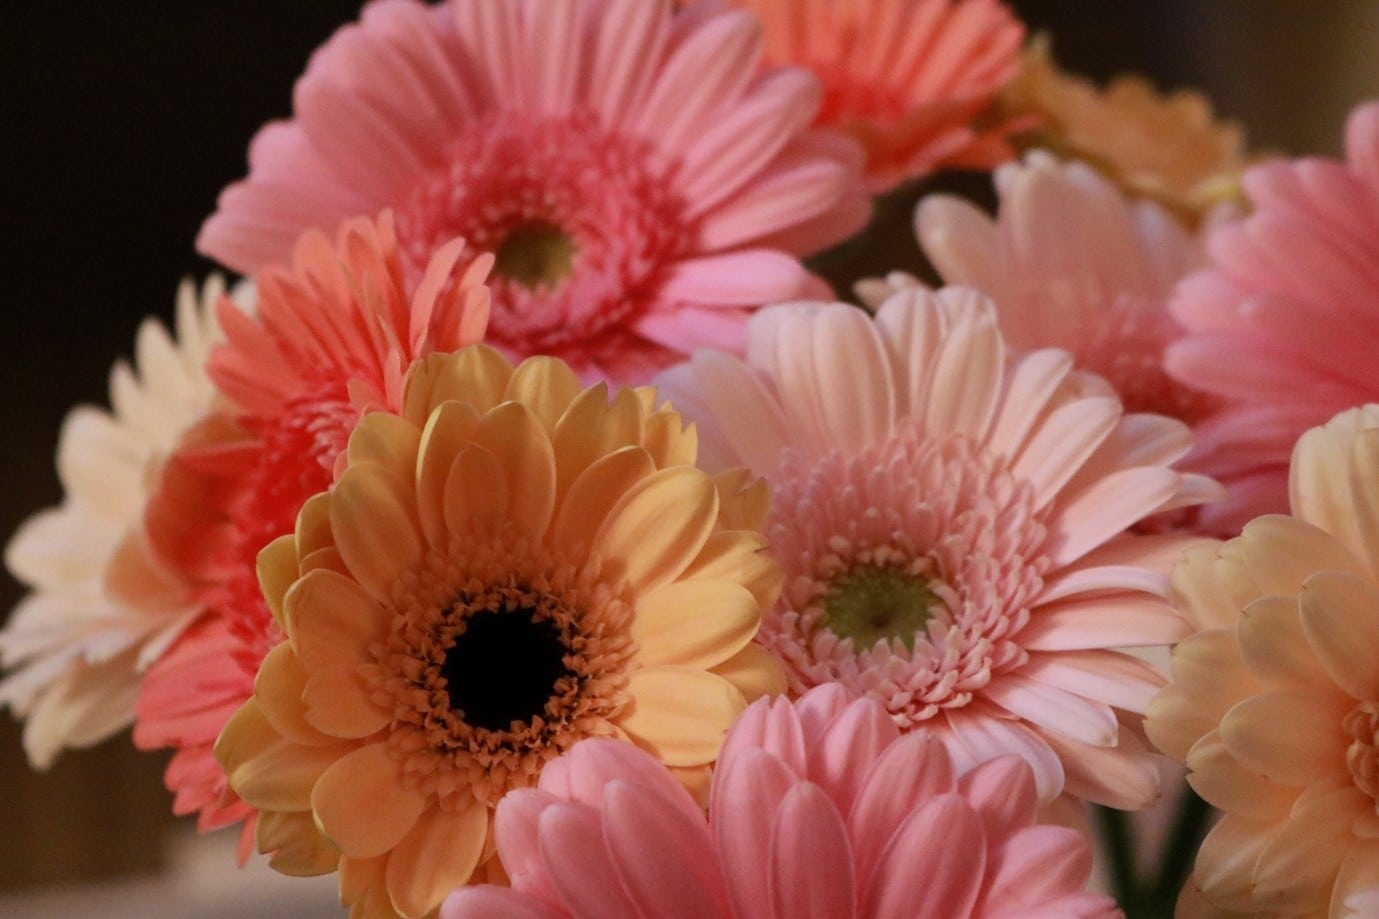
[821,566,940,650]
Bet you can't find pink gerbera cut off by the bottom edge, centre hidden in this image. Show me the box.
[440,687,1120,919]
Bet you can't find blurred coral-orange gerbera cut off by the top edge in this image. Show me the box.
[734,0,1029,192]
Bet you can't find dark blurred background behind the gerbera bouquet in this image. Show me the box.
[0,0,1379,890]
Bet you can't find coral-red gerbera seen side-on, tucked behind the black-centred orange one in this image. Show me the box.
[134,213,488,856]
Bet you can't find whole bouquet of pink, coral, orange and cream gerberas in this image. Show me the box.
[0,0,1379,919]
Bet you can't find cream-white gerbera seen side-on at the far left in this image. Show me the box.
[0,276,237,769]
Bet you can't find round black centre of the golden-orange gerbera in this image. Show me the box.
[440,606,572,731]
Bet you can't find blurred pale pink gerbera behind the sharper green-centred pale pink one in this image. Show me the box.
[910,150,1230,534]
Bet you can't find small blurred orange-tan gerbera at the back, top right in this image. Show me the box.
[1001,37,1245,221]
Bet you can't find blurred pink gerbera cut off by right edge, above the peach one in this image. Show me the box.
[1167,103,1379,522]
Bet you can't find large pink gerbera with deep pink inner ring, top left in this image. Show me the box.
[199,0,869,382]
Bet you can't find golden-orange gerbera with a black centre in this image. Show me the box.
[217,345,779,916]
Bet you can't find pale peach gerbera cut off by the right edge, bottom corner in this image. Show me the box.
[1147,404,1379,919]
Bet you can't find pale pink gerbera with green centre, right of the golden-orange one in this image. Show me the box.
[661,288,1219,807]
